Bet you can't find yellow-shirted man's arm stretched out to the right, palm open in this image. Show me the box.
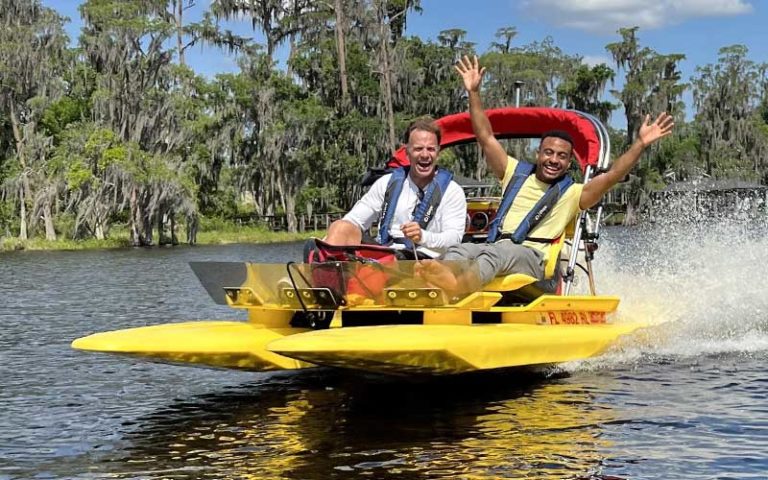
[579,112,675,210]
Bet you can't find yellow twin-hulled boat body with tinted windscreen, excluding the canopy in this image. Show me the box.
[72,261,642,375]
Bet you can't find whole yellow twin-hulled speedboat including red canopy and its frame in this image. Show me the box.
[72,108,645,375]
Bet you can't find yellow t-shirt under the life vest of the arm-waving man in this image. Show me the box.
[501,157,584,262]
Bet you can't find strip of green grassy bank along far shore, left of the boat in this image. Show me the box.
[0,225,325,252]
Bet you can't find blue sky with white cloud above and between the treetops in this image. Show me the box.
[42,0,768,127]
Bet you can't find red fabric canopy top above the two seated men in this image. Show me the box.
[387,107,600,171]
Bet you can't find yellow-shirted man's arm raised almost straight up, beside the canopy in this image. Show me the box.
[456,55,507,180]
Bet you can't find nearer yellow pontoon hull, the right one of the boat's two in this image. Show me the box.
[267,323,644,375]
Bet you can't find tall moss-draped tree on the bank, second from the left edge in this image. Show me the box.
[80,0,194,245]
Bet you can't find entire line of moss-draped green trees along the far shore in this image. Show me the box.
[0,0,768,248]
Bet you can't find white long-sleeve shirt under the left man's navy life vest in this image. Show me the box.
[344,174,467,255]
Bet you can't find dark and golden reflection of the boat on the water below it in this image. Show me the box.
[91,371,614,479]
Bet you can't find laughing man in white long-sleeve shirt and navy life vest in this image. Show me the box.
[325,117,467,257]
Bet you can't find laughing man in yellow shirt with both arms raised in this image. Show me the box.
[419,56,674,291]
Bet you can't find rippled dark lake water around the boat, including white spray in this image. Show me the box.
[0,225,768,480]
